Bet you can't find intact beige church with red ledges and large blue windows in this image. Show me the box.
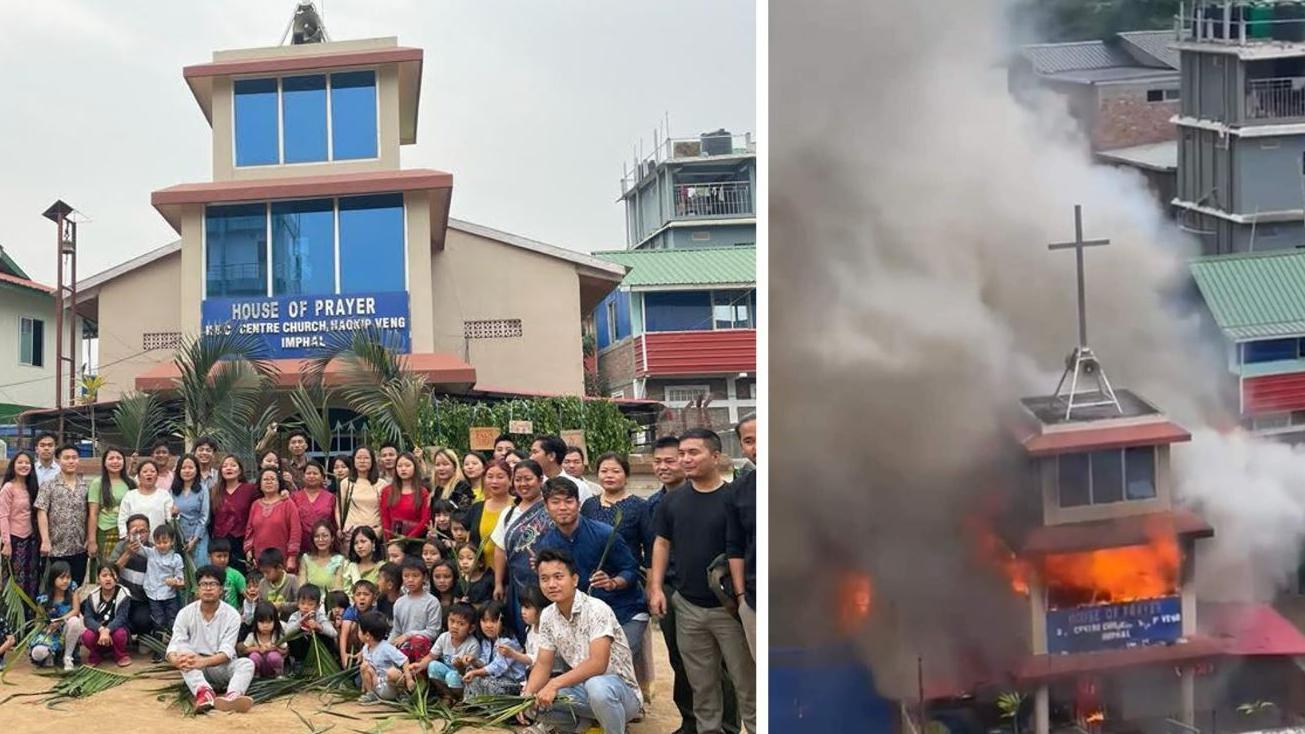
[71,32,625,400]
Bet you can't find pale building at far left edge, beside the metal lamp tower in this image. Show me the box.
[0,247,55,423]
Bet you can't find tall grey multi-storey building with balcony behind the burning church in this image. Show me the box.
[1172,0,1305,255]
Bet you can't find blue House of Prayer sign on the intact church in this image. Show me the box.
[200,291,411,359]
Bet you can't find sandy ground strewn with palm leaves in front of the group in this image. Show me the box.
[0,631,680,734]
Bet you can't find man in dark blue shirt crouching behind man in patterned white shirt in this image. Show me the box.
[535,477,649,656]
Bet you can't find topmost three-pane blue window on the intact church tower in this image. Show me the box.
[234,71,378,166]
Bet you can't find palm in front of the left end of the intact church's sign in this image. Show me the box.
[172,326,275,456]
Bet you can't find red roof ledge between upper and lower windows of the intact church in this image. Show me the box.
[150,168,453,208]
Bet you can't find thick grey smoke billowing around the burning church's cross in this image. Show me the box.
[770,0,1305,697]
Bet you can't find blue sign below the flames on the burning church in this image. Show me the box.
[1047,597,1182,654]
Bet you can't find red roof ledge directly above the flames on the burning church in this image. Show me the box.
[1021,511,1215,554]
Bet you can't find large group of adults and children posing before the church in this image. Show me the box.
[0,417,756,733]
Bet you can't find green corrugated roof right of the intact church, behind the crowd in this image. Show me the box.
[594,247,757,287]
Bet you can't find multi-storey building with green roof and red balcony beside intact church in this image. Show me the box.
[591,131,757,440]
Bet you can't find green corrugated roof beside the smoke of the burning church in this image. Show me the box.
[1190,249,1305,342]
